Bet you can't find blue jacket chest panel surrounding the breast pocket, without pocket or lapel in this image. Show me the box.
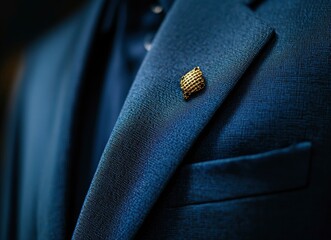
[137,1,331,239]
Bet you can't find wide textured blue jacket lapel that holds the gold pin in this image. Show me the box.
[73,0,274,239]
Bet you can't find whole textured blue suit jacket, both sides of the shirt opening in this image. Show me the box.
[1,0,331,239]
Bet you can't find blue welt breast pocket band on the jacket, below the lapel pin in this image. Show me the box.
[166,142,311,207]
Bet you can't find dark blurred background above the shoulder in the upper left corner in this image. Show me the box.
[0,0,85,162]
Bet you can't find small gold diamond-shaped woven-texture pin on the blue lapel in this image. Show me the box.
[180,67,205,100]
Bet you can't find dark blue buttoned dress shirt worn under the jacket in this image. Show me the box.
[68,0,171,234]
